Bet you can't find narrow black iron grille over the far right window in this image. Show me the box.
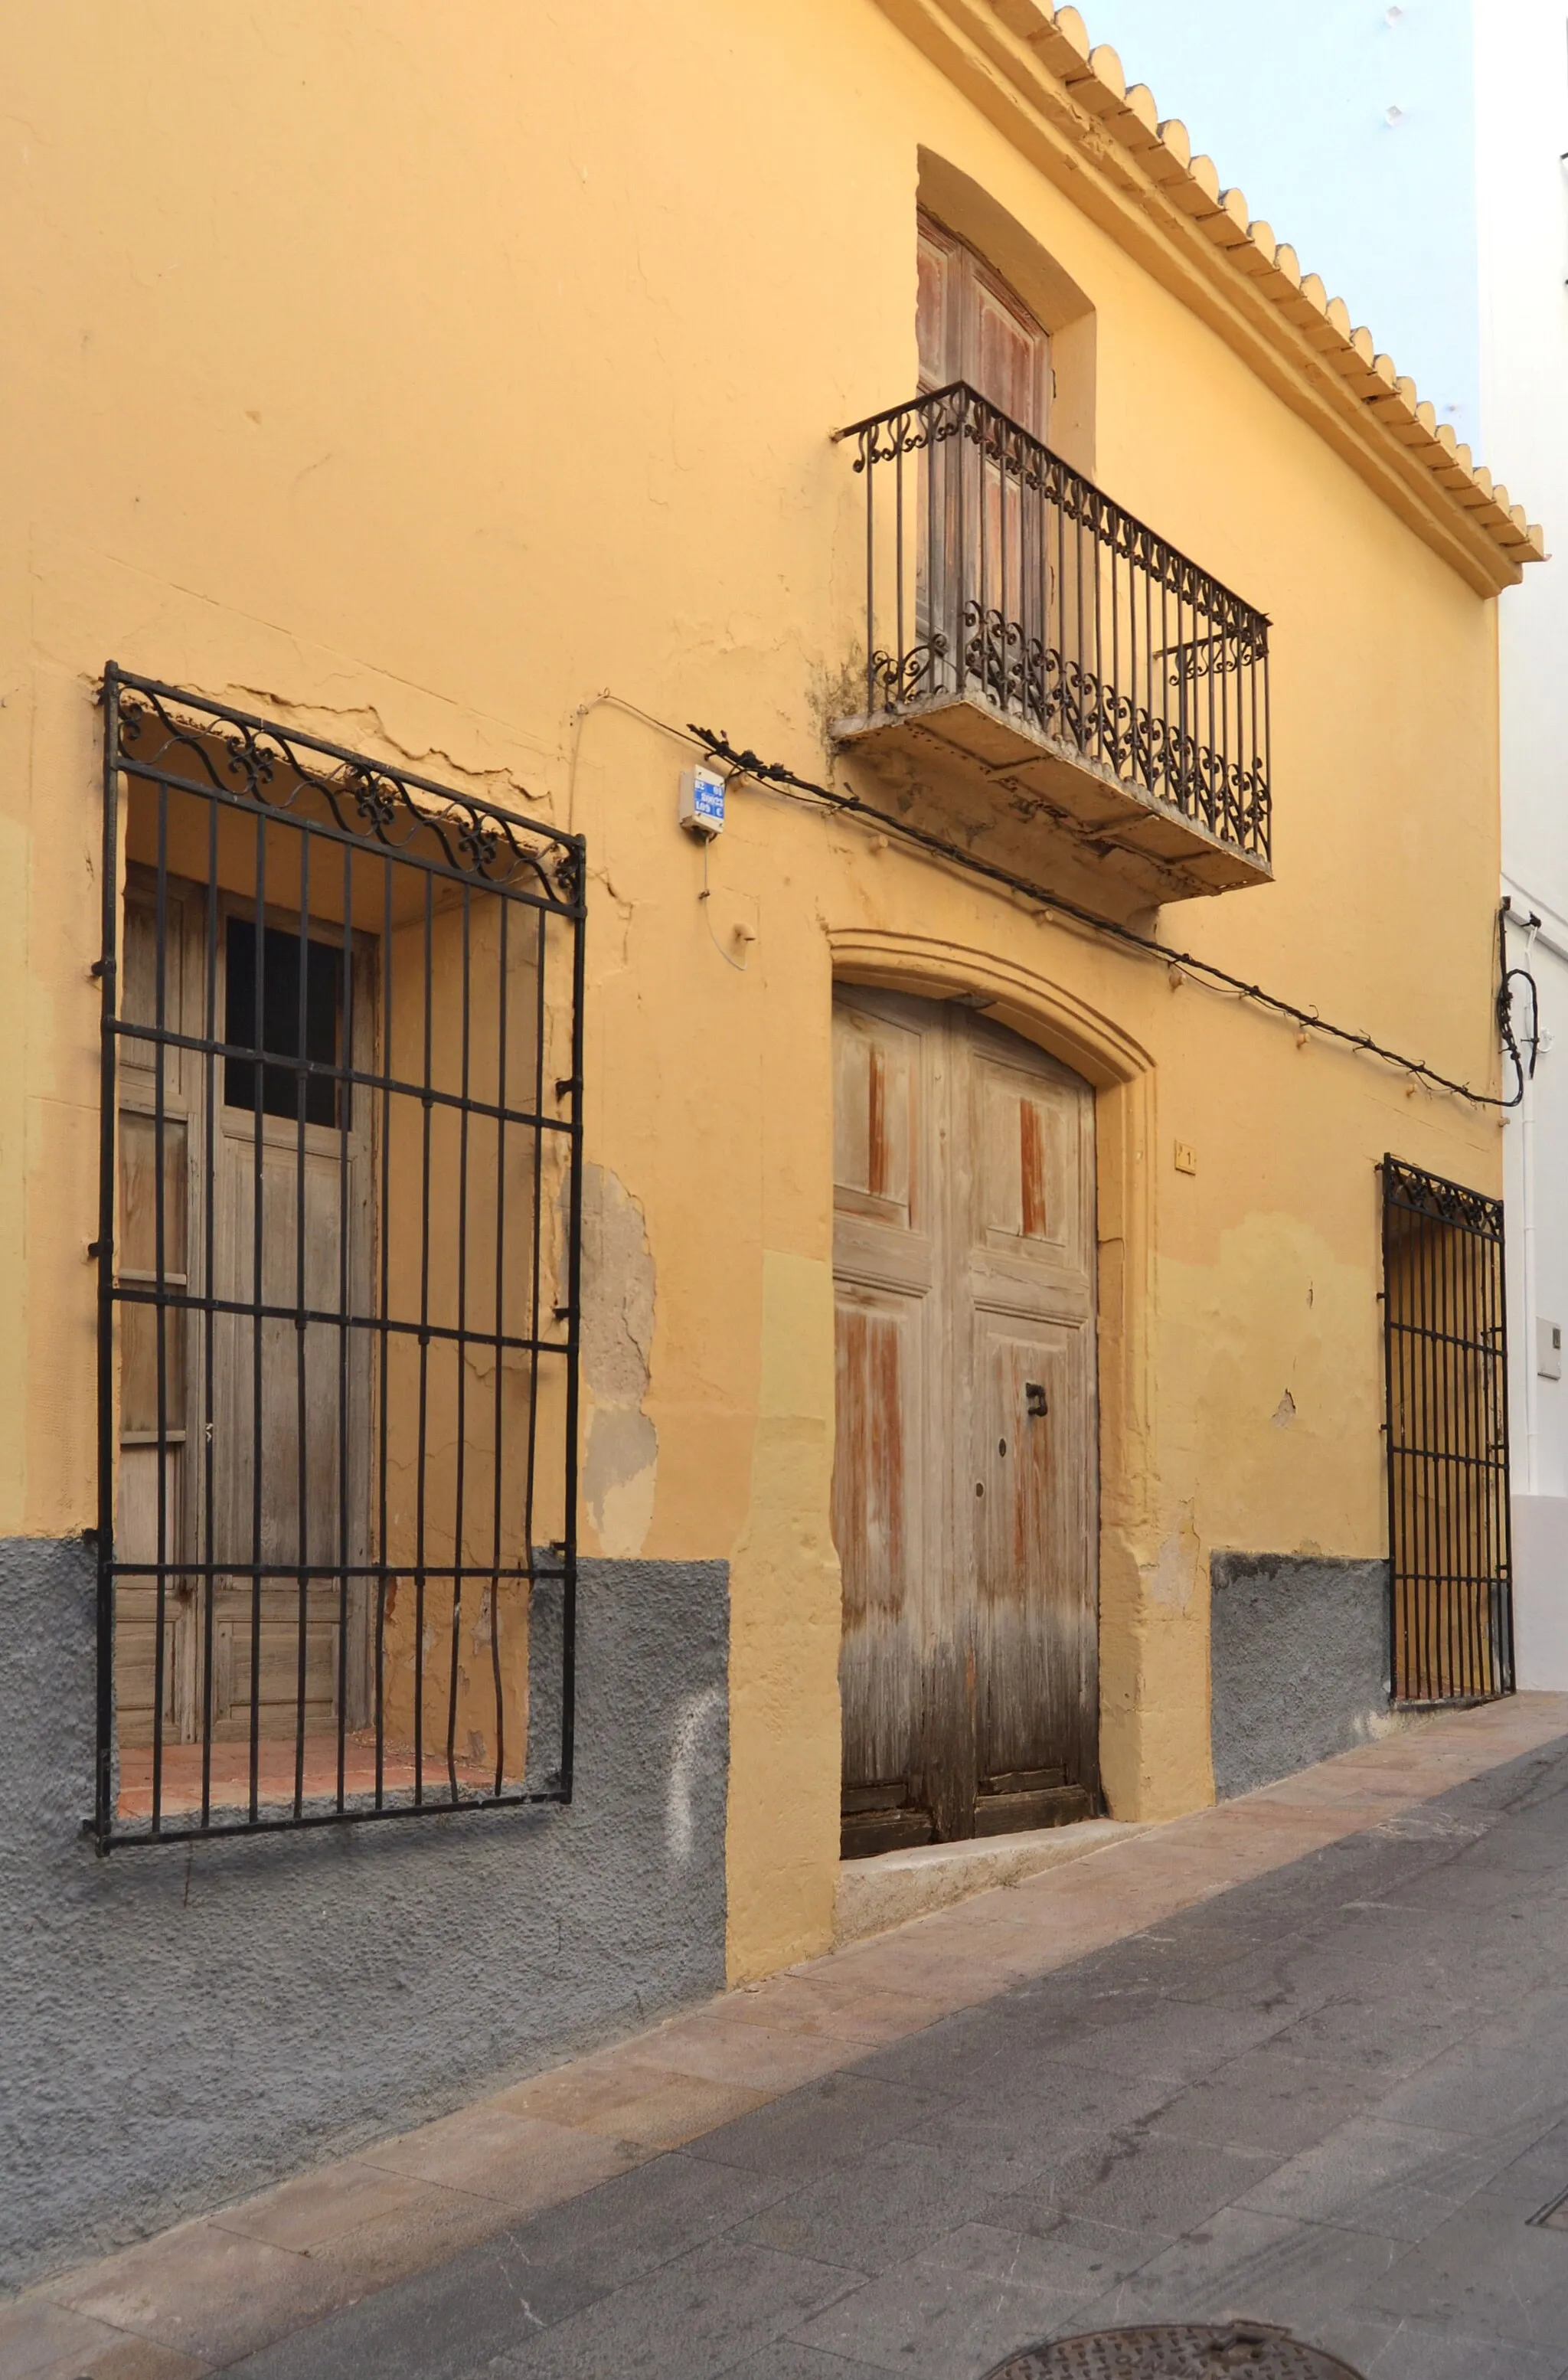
[1377,1156,1514,1709]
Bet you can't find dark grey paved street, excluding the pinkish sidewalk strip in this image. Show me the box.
[214,1742,1568,2380]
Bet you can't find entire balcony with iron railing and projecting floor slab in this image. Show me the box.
[833,381,1271,907]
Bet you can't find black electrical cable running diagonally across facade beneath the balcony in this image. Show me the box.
[561,688,1540,1111]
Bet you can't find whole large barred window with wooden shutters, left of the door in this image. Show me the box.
[86,664,586,1852]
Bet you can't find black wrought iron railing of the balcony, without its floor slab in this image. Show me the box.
[840,381,1268,888]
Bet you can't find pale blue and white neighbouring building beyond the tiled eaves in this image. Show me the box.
[1085,0,1568,1688]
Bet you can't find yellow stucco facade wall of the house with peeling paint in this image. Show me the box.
[0,0,1532,1980]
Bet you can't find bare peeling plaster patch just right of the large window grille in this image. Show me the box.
[583,1166,659,1559]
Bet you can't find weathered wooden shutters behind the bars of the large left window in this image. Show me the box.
[114,868,374,1747]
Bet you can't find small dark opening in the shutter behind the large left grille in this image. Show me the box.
[224,917,348,1130]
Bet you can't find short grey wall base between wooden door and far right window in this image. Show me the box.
[1209,1555,1390,1802]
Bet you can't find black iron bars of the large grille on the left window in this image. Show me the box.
[83,662,588,1852]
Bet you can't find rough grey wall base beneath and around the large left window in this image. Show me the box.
[0,1540,728,2287]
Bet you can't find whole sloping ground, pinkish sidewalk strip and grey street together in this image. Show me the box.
[0,1695,1568,2380]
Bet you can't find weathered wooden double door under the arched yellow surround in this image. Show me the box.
[833,990,1099,1856]
